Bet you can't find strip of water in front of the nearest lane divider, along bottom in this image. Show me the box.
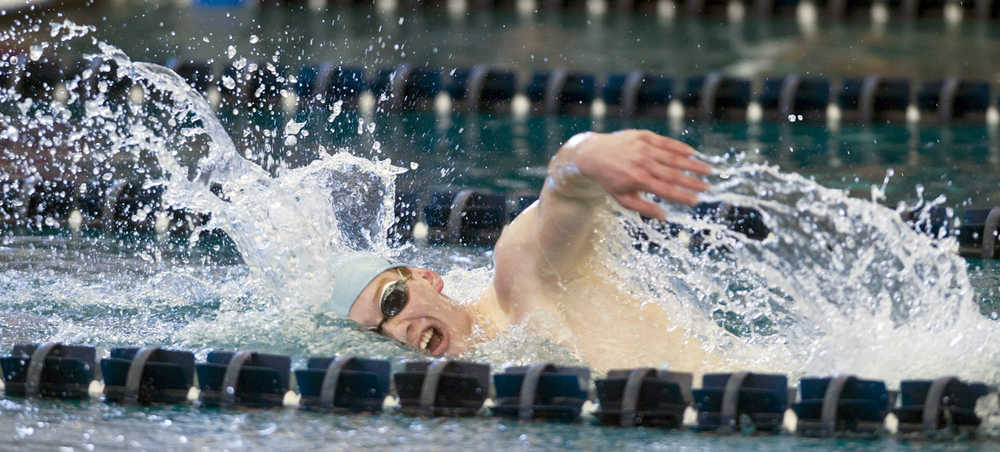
[11,401,993,451]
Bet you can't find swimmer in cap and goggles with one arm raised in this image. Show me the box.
[327,130,719,371]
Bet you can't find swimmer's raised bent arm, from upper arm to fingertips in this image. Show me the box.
[496,130,711,290]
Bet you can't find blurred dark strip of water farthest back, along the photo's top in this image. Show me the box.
[19,1,1000,80]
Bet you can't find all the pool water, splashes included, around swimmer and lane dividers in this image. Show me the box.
[0,3,1000,450]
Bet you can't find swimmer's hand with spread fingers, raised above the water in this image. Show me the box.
[546,130,712,220]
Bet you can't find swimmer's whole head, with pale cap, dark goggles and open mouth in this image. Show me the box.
[331,256,472,355]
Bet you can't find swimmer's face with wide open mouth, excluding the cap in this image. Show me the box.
[348,267,472,356]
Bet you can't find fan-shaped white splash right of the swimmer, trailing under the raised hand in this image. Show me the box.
[604,158,1000,381]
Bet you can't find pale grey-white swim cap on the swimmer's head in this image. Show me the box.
[325,254,404,317]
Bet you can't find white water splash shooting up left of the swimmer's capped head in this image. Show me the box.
[0,24,410,352]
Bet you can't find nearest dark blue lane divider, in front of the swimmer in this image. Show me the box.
[0,343,997,440]
